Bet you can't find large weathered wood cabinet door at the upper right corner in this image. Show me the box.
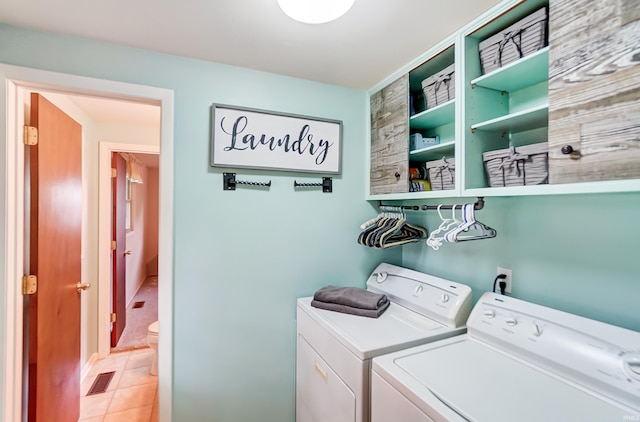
[549,0,640,183]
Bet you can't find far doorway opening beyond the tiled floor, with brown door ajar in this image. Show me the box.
[110,151,159,353]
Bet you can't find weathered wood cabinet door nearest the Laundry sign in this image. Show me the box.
[370,74,409,195]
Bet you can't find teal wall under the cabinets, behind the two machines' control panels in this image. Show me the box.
[403,193,640,331]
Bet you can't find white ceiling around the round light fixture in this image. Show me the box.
[0,0,499,90]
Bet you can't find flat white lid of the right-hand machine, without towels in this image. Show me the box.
[392,336,635,422]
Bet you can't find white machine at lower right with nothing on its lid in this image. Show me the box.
[372,293,640,422]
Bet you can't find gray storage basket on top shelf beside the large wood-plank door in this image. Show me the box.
[478,6,549,74]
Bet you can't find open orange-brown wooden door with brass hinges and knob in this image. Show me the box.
[25,93,82,422]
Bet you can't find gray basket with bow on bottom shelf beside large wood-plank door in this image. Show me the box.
[482,142,549,188]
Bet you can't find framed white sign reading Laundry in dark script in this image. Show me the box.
[211,104,342,174]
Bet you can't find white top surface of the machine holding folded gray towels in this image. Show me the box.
[298,297,465,360]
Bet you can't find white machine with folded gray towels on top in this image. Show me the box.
[296,263,472,422]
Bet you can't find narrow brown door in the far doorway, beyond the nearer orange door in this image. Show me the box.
[111,152,127,347]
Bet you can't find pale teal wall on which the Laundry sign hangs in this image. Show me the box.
[0,25,401,422]
